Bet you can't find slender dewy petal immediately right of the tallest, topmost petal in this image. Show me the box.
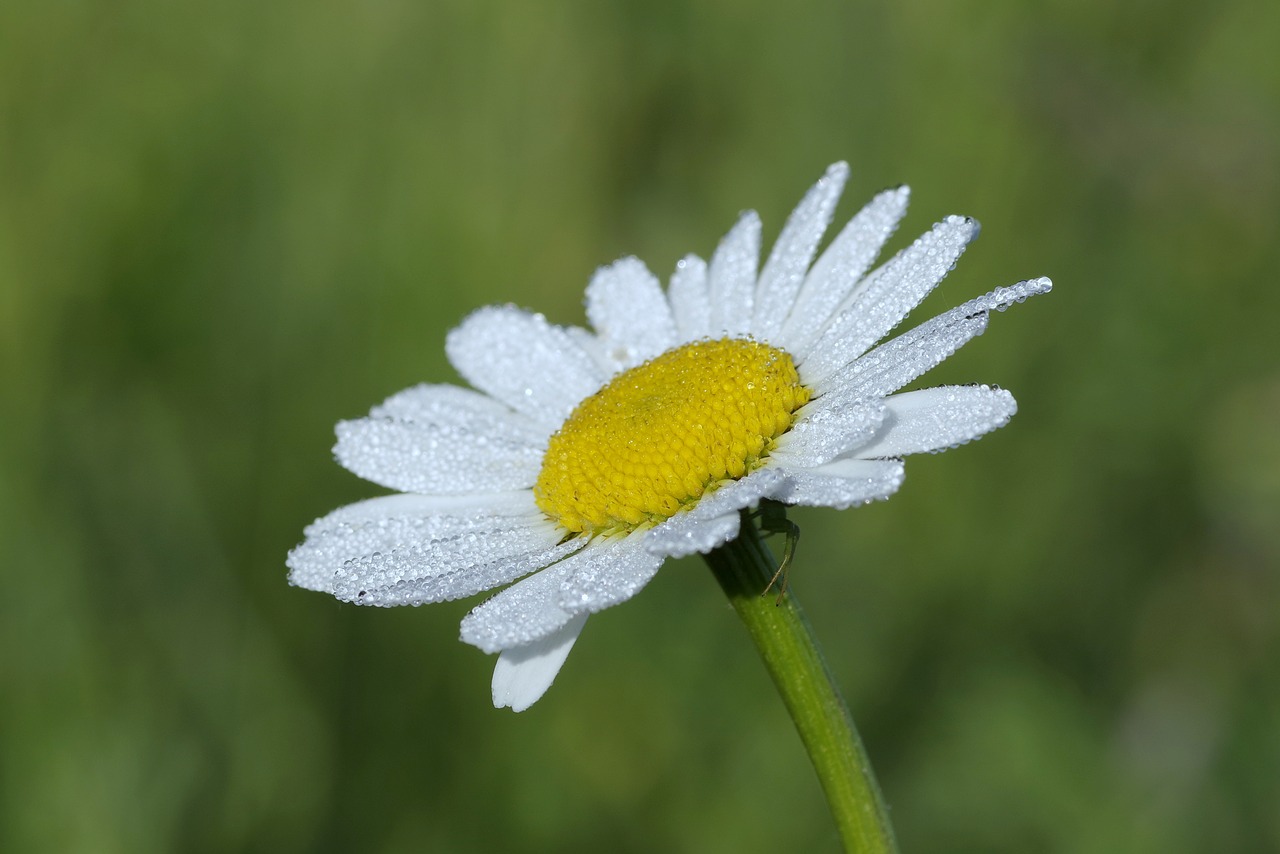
[777,187,910,353]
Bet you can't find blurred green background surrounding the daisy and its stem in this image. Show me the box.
[0,0,1280,853]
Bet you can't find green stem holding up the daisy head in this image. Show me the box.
[704,512,897,853]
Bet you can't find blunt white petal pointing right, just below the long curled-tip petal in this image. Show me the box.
[856,385,1018,458]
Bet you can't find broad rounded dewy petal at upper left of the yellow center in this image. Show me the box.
[444,306,605,429]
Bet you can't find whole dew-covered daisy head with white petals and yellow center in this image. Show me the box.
[288,163,1051,712]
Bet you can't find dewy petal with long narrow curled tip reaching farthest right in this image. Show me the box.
[800,278,1053,398]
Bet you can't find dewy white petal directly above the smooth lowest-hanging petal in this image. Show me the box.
[462,543,583,653]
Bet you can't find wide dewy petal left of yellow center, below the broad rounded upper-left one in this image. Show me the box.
[333,402,545,495]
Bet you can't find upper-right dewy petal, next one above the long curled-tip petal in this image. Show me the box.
[800,216,978,376]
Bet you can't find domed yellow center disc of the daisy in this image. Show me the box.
[534,338,810,535]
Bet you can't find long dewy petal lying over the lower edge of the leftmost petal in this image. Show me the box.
[333,520,582,607]
